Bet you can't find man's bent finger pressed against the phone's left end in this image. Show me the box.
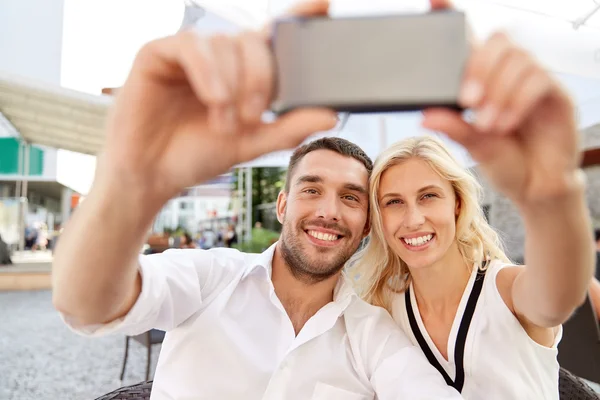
[239,32,274,125]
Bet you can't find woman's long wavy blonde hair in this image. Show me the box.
[350,136,509,312]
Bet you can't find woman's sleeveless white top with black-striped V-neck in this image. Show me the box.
[392,260,562,400]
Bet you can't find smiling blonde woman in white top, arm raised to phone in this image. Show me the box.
[355,28,593,400]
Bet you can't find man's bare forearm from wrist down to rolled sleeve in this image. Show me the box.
[52,180,160,325]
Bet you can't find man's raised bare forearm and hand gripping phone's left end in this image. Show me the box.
[53,0,337,324]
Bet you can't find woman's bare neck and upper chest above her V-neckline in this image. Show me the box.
[410,243,472,317]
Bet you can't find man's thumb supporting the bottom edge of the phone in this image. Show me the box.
[238,108,337,161]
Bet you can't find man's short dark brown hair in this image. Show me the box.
[285,137,373,193]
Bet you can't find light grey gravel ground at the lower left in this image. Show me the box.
[0,291,160,400]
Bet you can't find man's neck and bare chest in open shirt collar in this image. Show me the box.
[271,245,340,335]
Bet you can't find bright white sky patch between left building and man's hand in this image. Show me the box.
[61,0,184,94]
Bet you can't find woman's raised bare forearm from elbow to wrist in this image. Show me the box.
[511,171,595,328]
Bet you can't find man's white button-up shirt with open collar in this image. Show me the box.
[65,245,461,400]
